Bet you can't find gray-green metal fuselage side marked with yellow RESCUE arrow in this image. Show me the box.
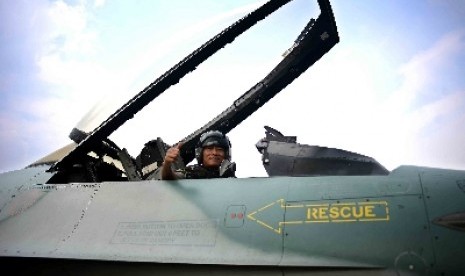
[0,167,465,275]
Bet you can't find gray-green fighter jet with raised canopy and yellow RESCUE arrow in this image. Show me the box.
[0,0,465,275]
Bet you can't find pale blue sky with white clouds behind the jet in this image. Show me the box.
[0,0,465,177]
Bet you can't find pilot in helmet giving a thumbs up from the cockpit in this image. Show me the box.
[161,130,236,180]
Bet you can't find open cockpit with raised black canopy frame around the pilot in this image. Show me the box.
[25,0,388,183]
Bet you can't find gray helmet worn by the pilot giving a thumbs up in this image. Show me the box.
[195,130,231,164]
